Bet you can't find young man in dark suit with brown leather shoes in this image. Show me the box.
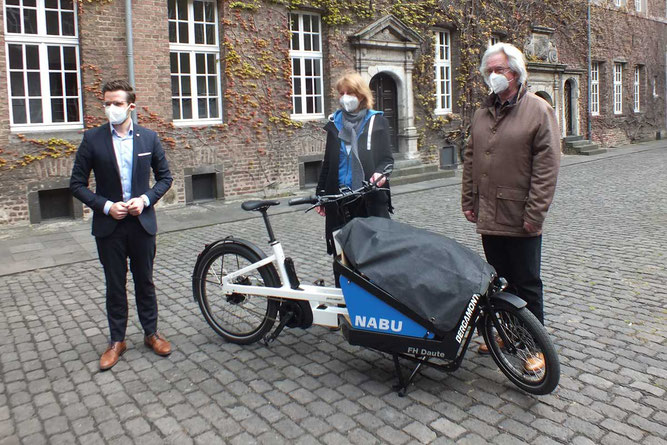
[70,80,173,370]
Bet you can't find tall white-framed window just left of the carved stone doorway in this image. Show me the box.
[289,12,324,119]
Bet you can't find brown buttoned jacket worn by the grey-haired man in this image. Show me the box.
[461,88,561,237]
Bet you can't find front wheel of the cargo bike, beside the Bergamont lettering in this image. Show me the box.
[482,302,560,395]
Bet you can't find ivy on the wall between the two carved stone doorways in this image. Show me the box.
[391,0,585,153]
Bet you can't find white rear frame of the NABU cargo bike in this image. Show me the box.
[221,241,348,327]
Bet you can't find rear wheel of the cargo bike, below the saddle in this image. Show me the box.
[193,243,280,344]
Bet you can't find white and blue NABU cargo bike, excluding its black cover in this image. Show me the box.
[193,180,559,396]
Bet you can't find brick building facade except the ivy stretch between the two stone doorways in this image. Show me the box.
[0,0,667,224]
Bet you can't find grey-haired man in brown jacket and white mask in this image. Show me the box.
[461,43,560,369]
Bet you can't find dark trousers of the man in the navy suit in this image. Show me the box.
[95,215,157,342]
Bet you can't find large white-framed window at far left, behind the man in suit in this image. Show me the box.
[4,0,83,131]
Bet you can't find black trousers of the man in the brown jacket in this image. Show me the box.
[482,235,544,324]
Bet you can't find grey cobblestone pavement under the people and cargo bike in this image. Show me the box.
[0,149,667,445]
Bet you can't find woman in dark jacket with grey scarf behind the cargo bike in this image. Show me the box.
[316,73,394,254]
